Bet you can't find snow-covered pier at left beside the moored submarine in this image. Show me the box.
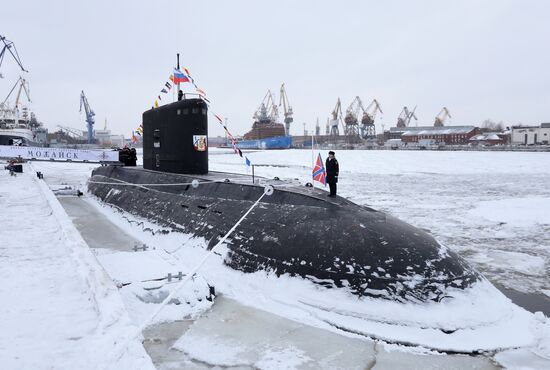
[0,165,154,369]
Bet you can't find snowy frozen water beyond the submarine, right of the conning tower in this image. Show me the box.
[205,149,550,292]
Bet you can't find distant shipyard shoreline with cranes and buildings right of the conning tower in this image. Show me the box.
[209,84,550,150]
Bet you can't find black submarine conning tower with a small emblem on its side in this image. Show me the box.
[143,99,208,175]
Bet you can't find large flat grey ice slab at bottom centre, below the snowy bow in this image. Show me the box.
[173,297,375,369]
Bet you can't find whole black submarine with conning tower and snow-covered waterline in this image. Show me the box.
[87,94,543,354]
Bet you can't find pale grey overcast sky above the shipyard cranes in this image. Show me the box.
[0,0,550,137]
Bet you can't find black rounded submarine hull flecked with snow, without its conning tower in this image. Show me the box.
[88,166,481,302]
